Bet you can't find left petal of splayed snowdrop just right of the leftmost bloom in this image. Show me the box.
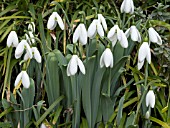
[15,40,27,59]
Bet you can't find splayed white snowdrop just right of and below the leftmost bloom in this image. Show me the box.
[15,40,32,59]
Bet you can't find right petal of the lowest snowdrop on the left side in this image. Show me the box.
[22,71,30,88]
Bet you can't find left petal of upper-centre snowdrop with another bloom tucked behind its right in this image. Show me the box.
[87,20,97,39]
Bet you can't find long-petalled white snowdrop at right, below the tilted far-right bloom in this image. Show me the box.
[138,42,151,70]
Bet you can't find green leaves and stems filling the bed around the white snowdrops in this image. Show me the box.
[0,0,170,128]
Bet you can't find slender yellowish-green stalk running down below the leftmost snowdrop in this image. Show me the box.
[2,47,13,99]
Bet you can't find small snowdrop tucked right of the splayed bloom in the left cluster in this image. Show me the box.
[24,47,41,63]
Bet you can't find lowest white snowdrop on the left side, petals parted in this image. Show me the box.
[14,71,30,88]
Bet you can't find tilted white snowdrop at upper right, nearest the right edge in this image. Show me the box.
[148,27,162,45]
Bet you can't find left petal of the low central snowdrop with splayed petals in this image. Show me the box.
[67,55,78,76]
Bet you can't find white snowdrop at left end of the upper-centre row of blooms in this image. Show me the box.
[73,23,87,45]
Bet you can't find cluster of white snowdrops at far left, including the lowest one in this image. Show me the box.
[7,22,41,88]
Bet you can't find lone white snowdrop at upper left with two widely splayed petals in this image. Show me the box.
[47,12,64,30]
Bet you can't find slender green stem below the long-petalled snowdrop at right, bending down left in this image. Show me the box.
[132,62,149,124]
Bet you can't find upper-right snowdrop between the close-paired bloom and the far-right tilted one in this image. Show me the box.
[125,25,141,42]
